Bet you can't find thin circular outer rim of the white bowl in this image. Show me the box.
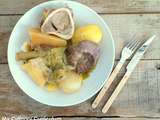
[7,0,115,107]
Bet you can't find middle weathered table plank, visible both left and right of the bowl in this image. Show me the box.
[0,14,160,63]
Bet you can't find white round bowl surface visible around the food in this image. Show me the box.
[8,1,115,106]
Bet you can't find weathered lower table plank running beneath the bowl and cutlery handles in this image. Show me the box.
[0,60,160,117]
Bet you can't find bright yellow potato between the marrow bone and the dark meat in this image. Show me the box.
[72,25,102,43]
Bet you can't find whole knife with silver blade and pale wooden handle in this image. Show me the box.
[102,35,156,113]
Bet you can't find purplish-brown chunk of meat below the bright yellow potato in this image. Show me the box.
[66,40,100,73]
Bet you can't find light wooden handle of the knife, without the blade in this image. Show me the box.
[102,73,130,113]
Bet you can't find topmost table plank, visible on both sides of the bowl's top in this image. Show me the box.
[0,0,160,14]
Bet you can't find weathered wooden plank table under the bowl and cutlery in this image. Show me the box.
[0,0,160,120]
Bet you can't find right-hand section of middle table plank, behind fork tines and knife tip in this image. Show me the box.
[102,14,160,59]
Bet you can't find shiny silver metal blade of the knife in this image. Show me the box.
[126,35,156,74]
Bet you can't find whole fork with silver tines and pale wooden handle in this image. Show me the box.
[92,38,140,108]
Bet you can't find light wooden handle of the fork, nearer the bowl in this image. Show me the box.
[92,61,124,108]
